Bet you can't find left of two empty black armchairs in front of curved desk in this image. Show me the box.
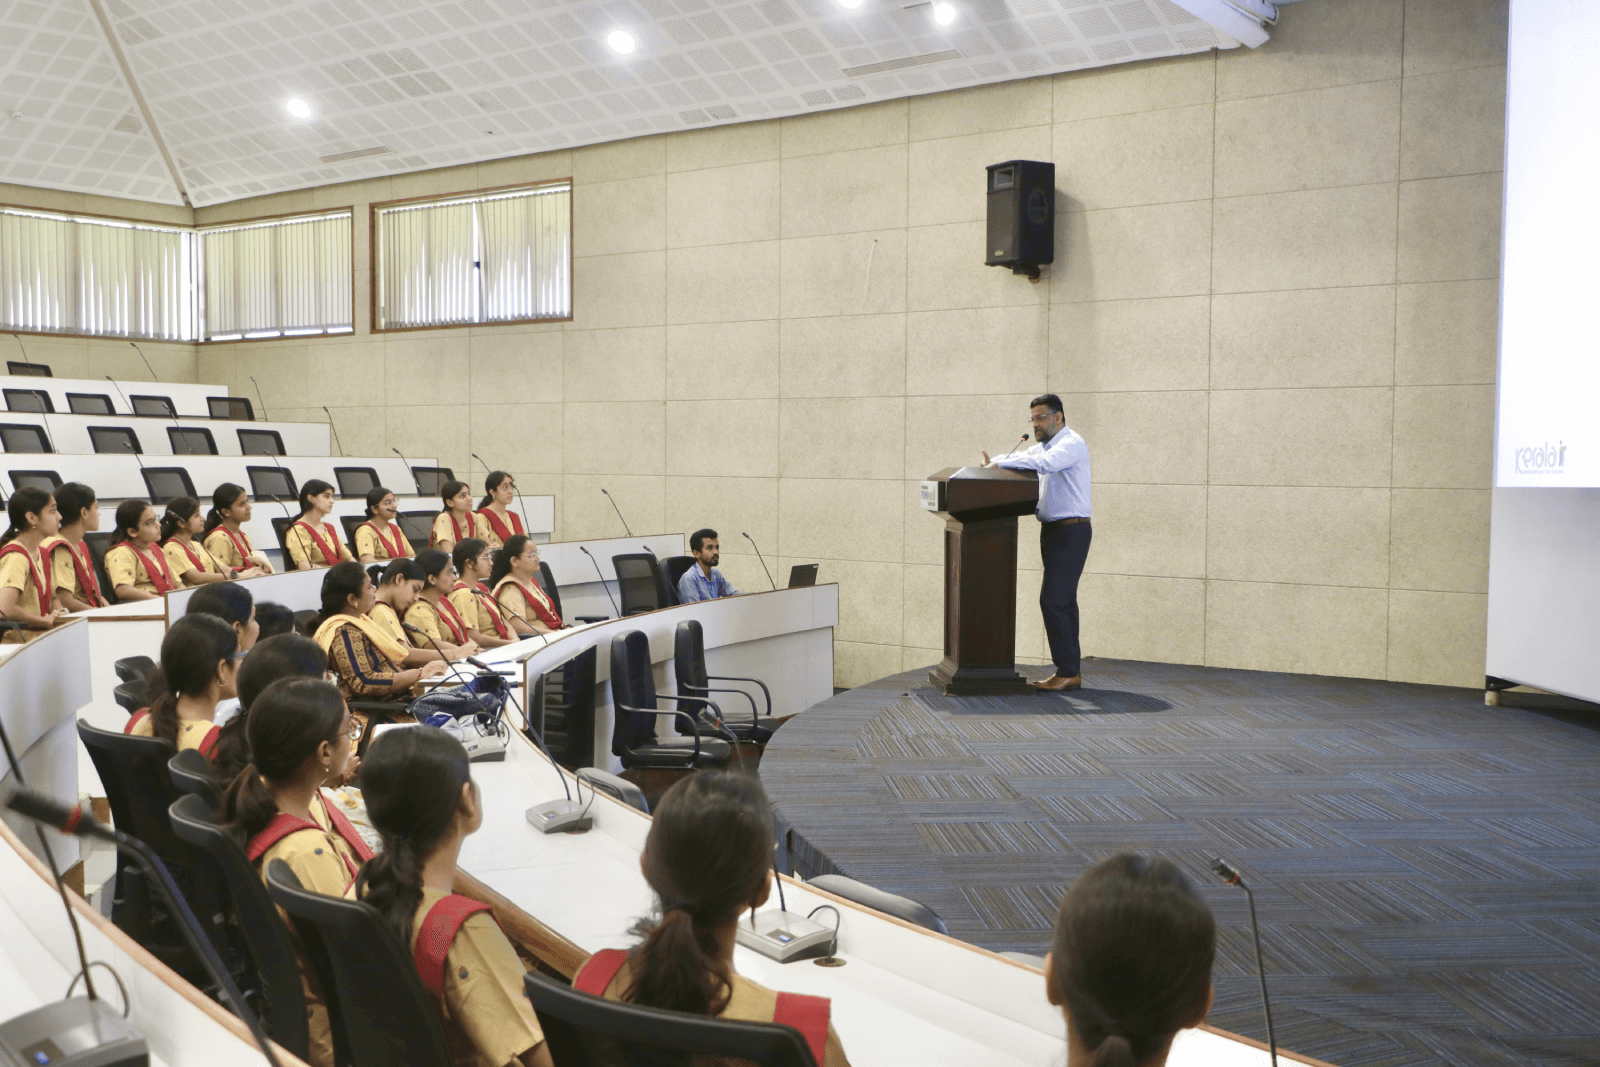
[611,630,733,771]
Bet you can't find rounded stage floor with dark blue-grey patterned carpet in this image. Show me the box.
[760,659,1600,1067]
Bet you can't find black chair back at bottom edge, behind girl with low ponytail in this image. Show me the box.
[522,971,818,1067]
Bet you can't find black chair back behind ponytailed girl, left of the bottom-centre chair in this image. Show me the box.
[266,859,454,1067]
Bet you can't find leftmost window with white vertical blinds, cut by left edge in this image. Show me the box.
[0,208,197,341]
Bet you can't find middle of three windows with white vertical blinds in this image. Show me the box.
[200,211,355,341]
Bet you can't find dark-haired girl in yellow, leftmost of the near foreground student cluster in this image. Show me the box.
[122,614,238,758]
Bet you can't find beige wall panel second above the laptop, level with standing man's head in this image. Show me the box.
[778,397,906,480]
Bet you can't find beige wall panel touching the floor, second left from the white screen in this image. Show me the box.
[1205,581,1389,678]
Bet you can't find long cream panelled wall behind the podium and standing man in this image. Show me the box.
[12,0,1506,685]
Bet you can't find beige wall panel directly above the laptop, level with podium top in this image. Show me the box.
[780,478,904,563]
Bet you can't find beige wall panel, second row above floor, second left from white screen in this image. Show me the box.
[1206,485,1389,587]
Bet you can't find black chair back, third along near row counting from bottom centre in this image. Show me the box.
[166,793,310,1059]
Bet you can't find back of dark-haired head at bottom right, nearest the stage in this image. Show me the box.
[1045,854,1216,1067]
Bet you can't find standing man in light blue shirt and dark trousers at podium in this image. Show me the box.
[984,394,1093,693]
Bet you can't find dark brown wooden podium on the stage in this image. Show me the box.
[922,467,1038,696]
